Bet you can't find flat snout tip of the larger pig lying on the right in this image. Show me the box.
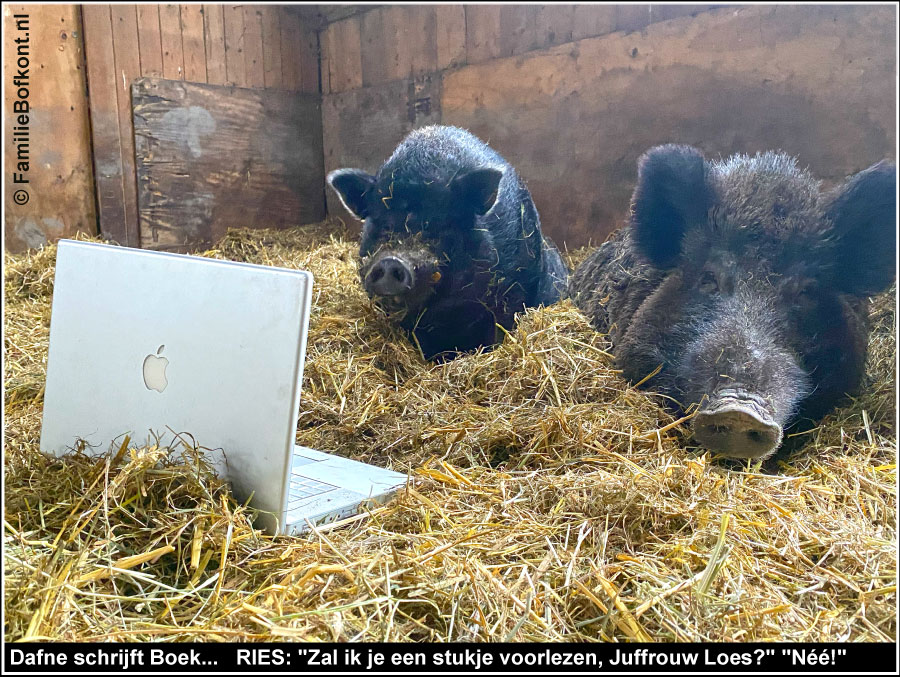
[693,391,784,458]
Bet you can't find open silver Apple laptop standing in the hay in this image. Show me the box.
[41,240,407,534]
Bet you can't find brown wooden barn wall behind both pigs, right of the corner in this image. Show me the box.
[321,5,896,247]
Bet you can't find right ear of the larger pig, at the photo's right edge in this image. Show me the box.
[826,160,897,296]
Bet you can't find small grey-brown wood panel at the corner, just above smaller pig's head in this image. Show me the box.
[322,76,441,223]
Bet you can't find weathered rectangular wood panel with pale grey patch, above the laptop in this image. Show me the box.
[133,78,324,251]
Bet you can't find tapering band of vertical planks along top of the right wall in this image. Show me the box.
[318,3,717,84]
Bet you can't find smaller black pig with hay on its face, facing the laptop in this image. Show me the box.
[328,126,568,359]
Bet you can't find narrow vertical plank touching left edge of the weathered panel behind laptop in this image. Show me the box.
[110,5,142,246]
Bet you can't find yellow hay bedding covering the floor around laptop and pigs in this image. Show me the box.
[4,224,897,641]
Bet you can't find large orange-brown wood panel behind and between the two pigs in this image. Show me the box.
[442,5,897,246]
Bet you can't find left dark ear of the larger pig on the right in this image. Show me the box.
[631,144,709,268]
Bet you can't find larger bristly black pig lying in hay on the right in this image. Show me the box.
[569,145,897,458]
